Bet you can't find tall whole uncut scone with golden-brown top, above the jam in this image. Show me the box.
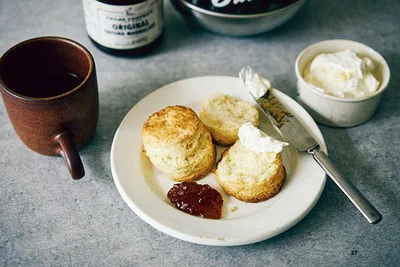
[142,106,215,182]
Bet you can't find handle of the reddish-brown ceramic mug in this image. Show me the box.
[54,132,85,180]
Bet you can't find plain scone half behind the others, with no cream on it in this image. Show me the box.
[200,94,259,146]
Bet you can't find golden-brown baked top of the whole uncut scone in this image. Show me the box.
[142,106,200,146]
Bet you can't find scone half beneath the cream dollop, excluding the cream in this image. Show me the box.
[215,140,286,202]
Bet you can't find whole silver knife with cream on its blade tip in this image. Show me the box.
[239,67,382,223]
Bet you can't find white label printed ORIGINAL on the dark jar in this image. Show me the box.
[83,0,163,49]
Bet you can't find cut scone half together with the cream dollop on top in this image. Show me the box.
[215,123,288,202]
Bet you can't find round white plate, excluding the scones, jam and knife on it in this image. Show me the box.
[111,76,326,246]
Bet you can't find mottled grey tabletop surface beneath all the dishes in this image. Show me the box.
[0,0,400,266]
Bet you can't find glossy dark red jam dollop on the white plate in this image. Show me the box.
[167,182,223,219]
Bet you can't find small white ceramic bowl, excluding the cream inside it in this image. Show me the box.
[295,40,390,127]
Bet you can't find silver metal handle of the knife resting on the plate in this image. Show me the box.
[308,149,382,224]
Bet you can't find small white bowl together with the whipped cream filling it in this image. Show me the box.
[295,40,390,127]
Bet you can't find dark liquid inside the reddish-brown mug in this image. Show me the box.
[19,72,82,98]
